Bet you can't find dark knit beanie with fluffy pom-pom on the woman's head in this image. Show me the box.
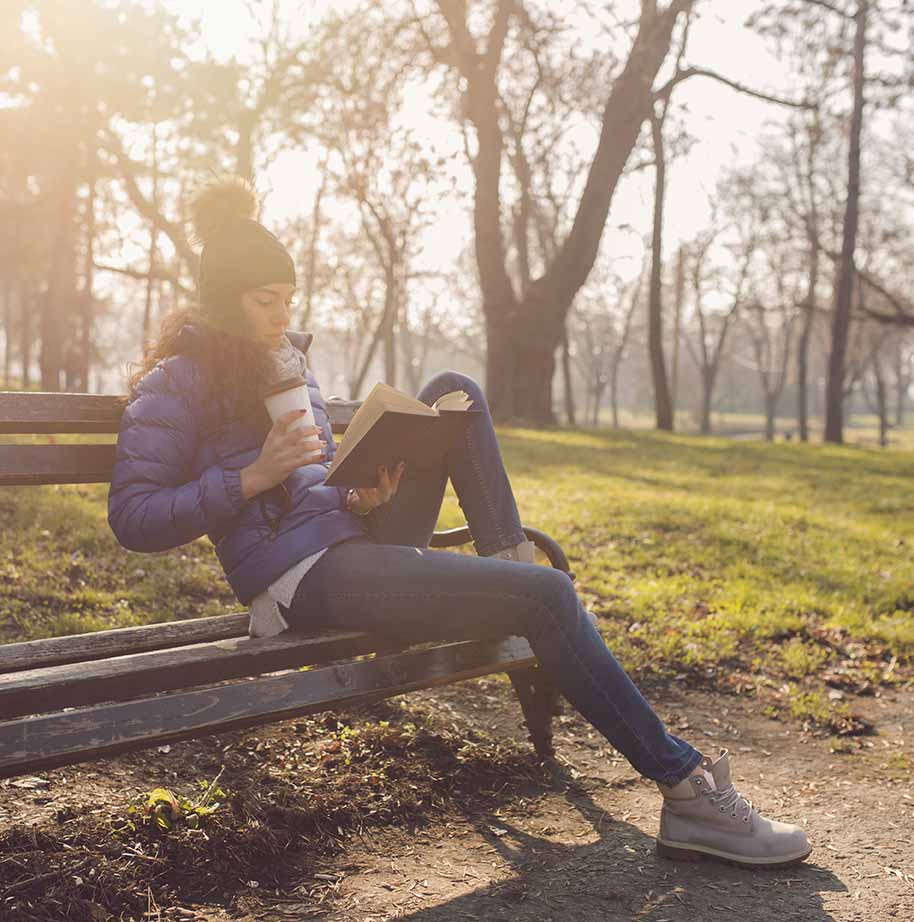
[190,176,295,306]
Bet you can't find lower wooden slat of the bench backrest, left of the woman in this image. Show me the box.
[0,445,115,487]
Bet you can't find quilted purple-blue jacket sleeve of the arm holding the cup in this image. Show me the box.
[108,365,244,551]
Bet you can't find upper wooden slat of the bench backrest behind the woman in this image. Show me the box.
[0,391,361,435]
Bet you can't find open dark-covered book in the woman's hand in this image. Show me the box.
[325,384,479,487]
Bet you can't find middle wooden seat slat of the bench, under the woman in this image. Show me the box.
[0,631,404,717]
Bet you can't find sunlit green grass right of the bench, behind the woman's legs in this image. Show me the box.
[444,430,914,678]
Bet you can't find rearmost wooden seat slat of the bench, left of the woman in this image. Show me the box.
[0,612,249,673]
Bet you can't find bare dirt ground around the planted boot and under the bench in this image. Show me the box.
[0,678,914,922]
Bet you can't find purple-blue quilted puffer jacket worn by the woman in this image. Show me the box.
[108,324,365,605]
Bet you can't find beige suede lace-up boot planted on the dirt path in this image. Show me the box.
[657,749,812,868]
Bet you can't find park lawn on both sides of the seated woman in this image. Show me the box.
[0,429,914,724]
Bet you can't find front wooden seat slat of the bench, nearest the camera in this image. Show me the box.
[0,637,536,777]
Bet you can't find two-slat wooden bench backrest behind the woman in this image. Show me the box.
[0,391,360,486]
